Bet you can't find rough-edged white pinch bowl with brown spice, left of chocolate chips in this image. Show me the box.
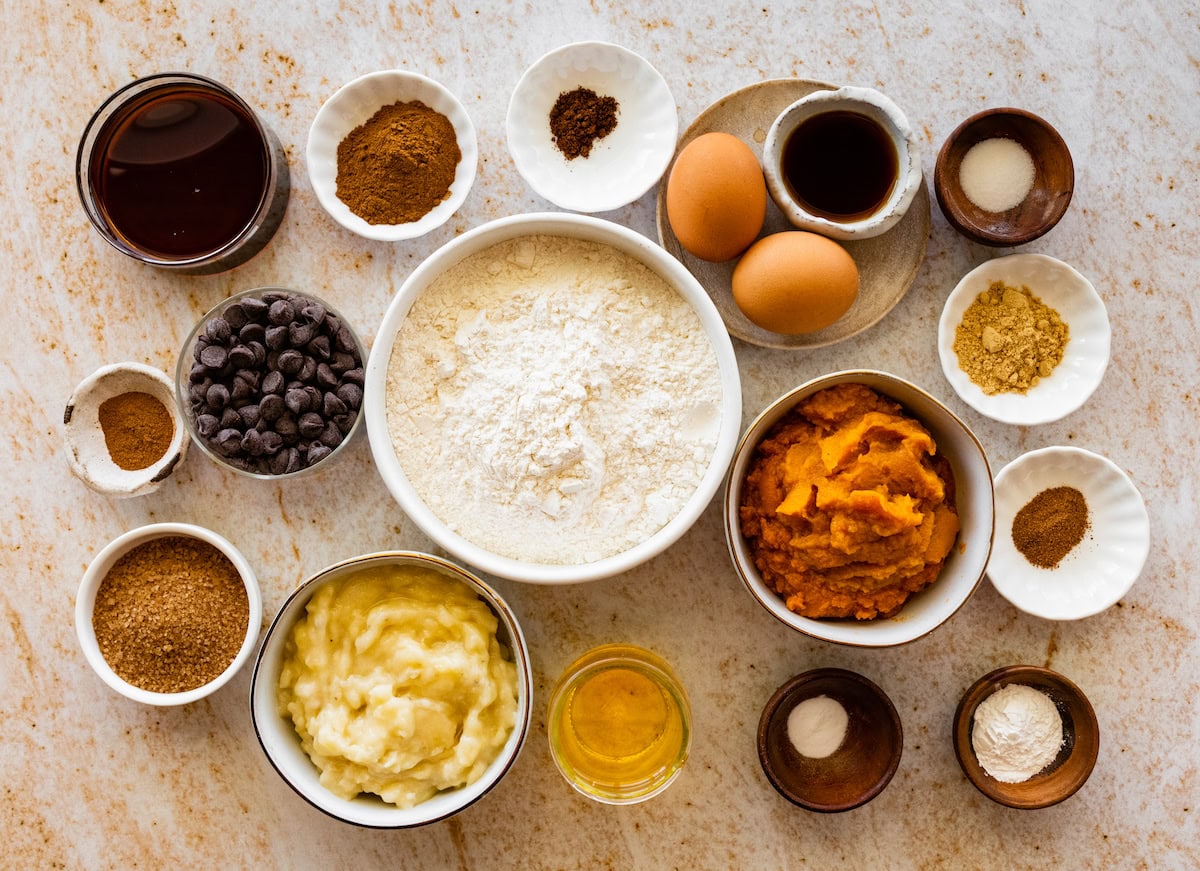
[62,362,190,498]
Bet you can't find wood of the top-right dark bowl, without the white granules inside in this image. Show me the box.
[934,108,1075,247]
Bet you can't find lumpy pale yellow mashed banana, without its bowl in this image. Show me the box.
[278,565,517,807]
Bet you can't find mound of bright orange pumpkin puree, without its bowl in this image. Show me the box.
[739,384,959,620]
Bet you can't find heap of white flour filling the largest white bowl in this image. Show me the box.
[386,236,721,564]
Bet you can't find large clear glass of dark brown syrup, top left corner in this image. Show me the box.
[76,73,290,274]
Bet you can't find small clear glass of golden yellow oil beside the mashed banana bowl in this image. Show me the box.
[546,644,691,804]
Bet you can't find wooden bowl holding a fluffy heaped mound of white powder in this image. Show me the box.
[954,666,1100,810]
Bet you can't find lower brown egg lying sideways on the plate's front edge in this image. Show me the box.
[733,230,858,335]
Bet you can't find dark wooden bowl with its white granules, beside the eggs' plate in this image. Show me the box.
[934,108,1075,247]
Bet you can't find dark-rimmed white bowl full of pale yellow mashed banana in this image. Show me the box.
[250,551,533,829]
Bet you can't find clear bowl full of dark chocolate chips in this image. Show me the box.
[175,287,366,479]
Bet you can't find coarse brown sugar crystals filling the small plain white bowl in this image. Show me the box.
[92,535,250,692]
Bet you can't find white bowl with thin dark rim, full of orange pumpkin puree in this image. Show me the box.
[725,370,995,647]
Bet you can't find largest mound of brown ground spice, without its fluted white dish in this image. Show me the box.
[337,100,462,224]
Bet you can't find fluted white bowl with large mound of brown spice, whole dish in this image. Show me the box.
[305,70,479,242]
